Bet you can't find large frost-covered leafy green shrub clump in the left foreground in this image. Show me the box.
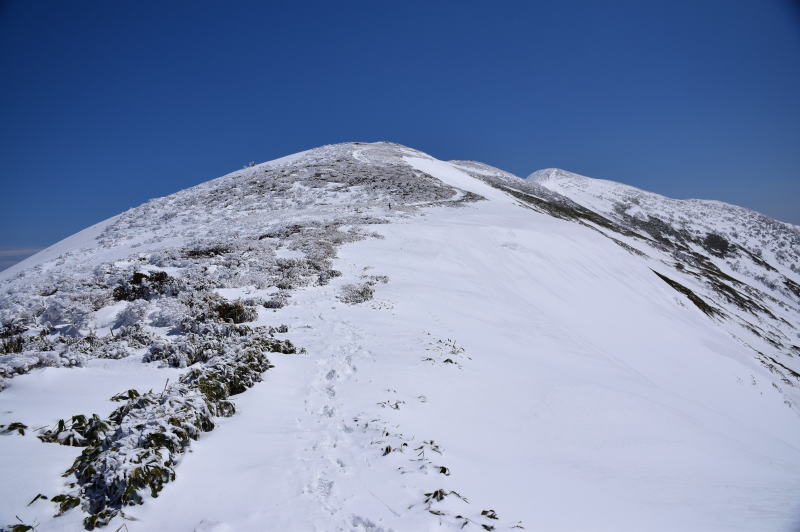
[41,340,278,530]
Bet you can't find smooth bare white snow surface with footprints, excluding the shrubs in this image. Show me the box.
[0,144,800,532]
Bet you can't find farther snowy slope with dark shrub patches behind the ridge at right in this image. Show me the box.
[530,169,800,383]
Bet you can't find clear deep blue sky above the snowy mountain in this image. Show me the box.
[0,0,800,266]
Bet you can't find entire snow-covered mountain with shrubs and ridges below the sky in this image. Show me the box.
[0,143,800,532]
